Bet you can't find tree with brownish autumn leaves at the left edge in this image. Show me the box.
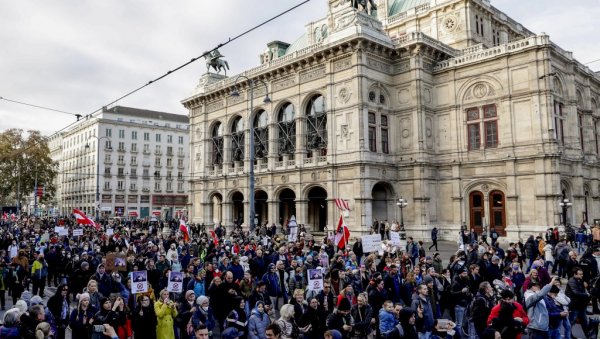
[0,128,58,210]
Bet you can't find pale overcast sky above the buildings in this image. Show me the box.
[0,0,600,138]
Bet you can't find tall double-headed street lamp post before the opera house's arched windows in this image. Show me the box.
[231,75,271,234]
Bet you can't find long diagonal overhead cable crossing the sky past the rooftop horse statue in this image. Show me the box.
[0,0,311,161]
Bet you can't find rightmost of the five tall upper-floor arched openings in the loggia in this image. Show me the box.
[306,94,327,158]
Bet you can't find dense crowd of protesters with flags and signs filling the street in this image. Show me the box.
[0,217,600,339]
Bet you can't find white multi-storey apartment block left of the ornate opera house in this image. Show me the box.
[54,106,189,222]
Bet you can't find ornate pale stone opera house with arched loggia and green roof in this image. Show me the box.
[182,0,600,240]
